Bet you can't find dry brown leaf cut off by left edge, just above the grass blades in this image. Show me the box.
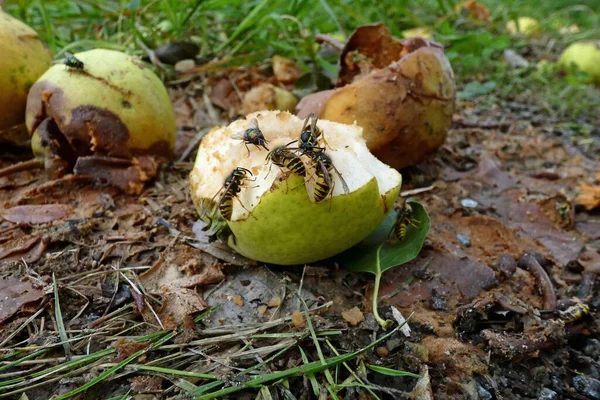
[0,277,44,324]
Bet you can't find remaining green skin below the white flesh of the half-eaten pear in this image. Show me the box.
[229,174,400,265]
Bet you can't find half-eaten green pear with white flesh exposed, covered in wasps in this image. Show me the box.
[190,111,402,265]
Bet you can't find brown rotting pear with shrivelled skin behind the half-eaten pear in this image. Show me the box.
[296,24,456,168]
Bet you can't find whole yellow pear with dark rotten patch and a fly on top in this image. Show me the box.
[26,49,176,193]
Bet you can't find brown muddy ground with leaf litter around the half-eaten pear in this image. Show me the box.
[0,92,600,399]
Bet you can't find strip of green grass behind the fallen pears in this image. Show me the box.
[5,0,600,122]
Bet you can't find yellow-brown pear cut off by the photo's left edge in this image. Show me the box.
[0,10,52,143]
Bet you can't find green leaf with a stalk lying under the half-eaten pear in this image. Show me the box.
[341,199,430,275]
